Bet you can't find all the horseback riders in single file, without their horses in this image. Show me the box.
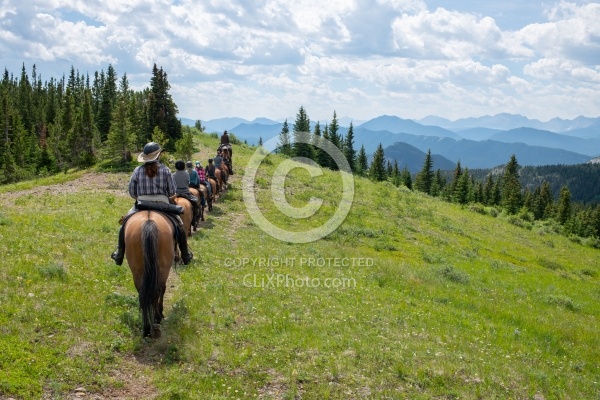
[111,131,233,265]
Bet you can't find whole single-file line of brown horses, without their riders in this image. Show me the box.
[124,147,231,338]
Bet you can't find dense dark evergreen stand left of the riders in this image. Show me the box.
[0,64,191,184]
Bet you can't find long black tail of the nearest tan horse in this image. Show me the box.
[140,220,158,333]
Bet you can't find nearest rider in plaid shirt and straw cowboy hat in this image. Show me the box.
[111,142,193,265]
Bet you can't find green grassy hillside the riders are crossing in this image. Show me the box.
[0,137,600,399]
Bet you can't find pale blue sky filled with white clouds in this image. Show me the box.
[0,0,600,121]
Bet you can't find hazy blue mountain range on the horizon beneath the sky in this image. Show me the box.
[182,114,600,172]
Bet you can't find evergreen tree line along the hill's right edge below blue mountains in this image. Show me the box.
[277,107,600,242]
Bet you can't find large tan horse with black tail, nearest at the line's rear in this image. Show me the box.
[125,211,175,338]
